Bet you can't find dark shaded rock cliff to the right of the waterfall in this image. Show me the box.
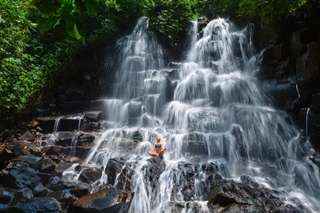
[255,3,320,150]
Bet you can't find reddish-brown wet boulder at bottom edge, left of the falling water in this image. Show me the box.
[69,186,131,213]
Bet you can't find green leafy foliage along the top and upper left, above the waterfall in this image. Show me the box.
[0,0,306,114]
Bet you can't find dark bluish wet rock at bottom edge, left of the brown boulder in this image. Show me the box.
[9,197,62,213]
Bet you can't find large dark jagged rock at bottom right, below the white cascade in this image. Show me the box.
[208,177,308,212]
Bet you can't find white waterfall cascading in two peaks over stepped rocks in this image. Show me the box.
[65,18,320,213]
